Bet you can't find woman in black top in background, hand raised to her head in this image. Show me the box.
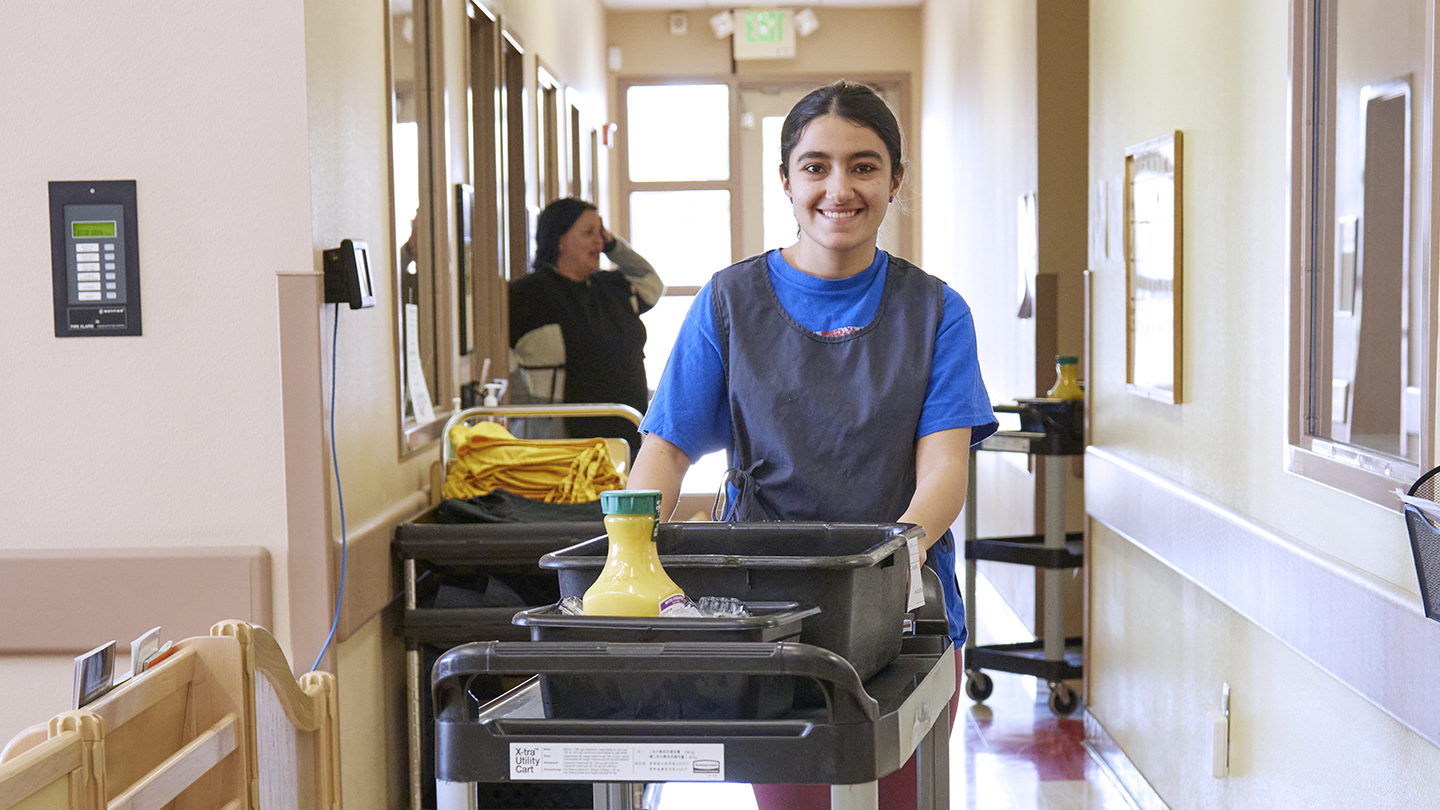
[510,197,665,455]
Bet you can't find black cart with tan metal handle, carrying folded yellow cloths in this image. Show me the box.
[392,404,641,810]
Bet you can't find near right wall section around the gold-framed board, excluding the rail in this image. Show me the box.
[1089,0,1440,810]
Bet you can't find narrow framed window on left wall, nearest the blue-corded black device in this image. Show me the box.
[389,0,436,425]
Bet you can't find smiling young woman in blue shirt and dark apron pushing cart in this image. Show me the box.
[629,81,996,809]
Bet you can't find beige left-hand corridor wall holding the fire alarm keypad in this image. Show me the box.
[0,6,608,807]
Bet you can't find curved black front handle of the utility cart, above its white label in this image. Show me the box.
[432,641,880,725]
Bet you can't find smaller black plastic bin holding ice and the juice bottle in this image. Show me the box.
[516,602,819,721]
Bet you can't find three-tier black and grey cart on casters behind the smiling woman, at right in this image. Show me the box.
[965,399,1084,715]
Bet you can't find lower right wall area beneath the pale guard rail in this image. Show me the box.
[1089,526,1440,810]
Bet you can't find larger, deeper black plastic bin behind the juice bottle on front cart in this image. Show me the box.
[540,522,920,680]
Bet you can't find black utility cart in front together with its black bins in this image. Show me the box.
[432,523,956,810]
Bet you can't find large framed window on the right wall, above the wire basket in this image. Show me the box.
[1289,0,1434,506]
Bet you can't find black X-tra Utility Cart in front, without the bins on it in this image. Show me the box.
[433,581,955,810]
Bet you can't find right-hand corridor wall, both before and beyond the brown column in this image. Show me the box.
[923,0,1440,795]
